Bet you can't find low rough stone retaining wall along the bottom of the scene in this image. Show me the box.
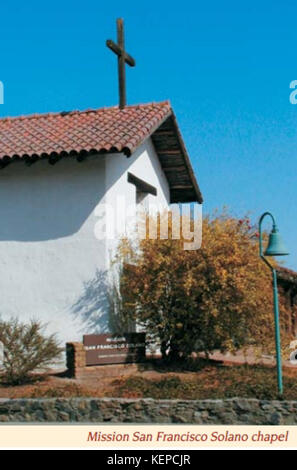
[0,398,297,425]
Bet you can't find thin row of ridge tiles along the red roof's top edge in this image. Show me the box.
[0,100,171,122]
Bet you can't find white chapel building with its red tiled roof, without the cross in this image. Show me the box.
[0,101,202,344]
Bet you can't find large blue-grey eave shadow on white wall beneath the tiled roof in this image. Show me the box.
[0,159,105,242]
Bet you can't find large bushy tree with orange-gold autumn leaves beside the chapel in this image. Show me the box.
[116,212,288,360]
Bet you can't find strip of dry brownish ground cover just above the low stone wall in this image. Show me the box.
[0,360,297,400]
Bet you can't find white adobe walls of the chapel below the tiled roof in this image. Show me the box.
[0,139,169,354]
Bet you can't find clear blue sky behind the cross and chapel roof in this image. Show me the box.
[0,0,297,270]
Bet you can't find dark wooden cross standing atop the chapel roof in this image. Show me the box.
[106,18,135,109]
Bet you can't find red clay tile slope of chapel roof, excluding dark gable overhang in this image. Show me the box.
[0,101,171,159]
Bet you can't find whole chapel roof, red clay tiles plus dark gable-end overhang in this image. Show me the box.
[0,101,202,203]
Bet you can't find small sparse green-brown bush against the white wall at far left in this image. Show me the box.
[0,319,63,384]
